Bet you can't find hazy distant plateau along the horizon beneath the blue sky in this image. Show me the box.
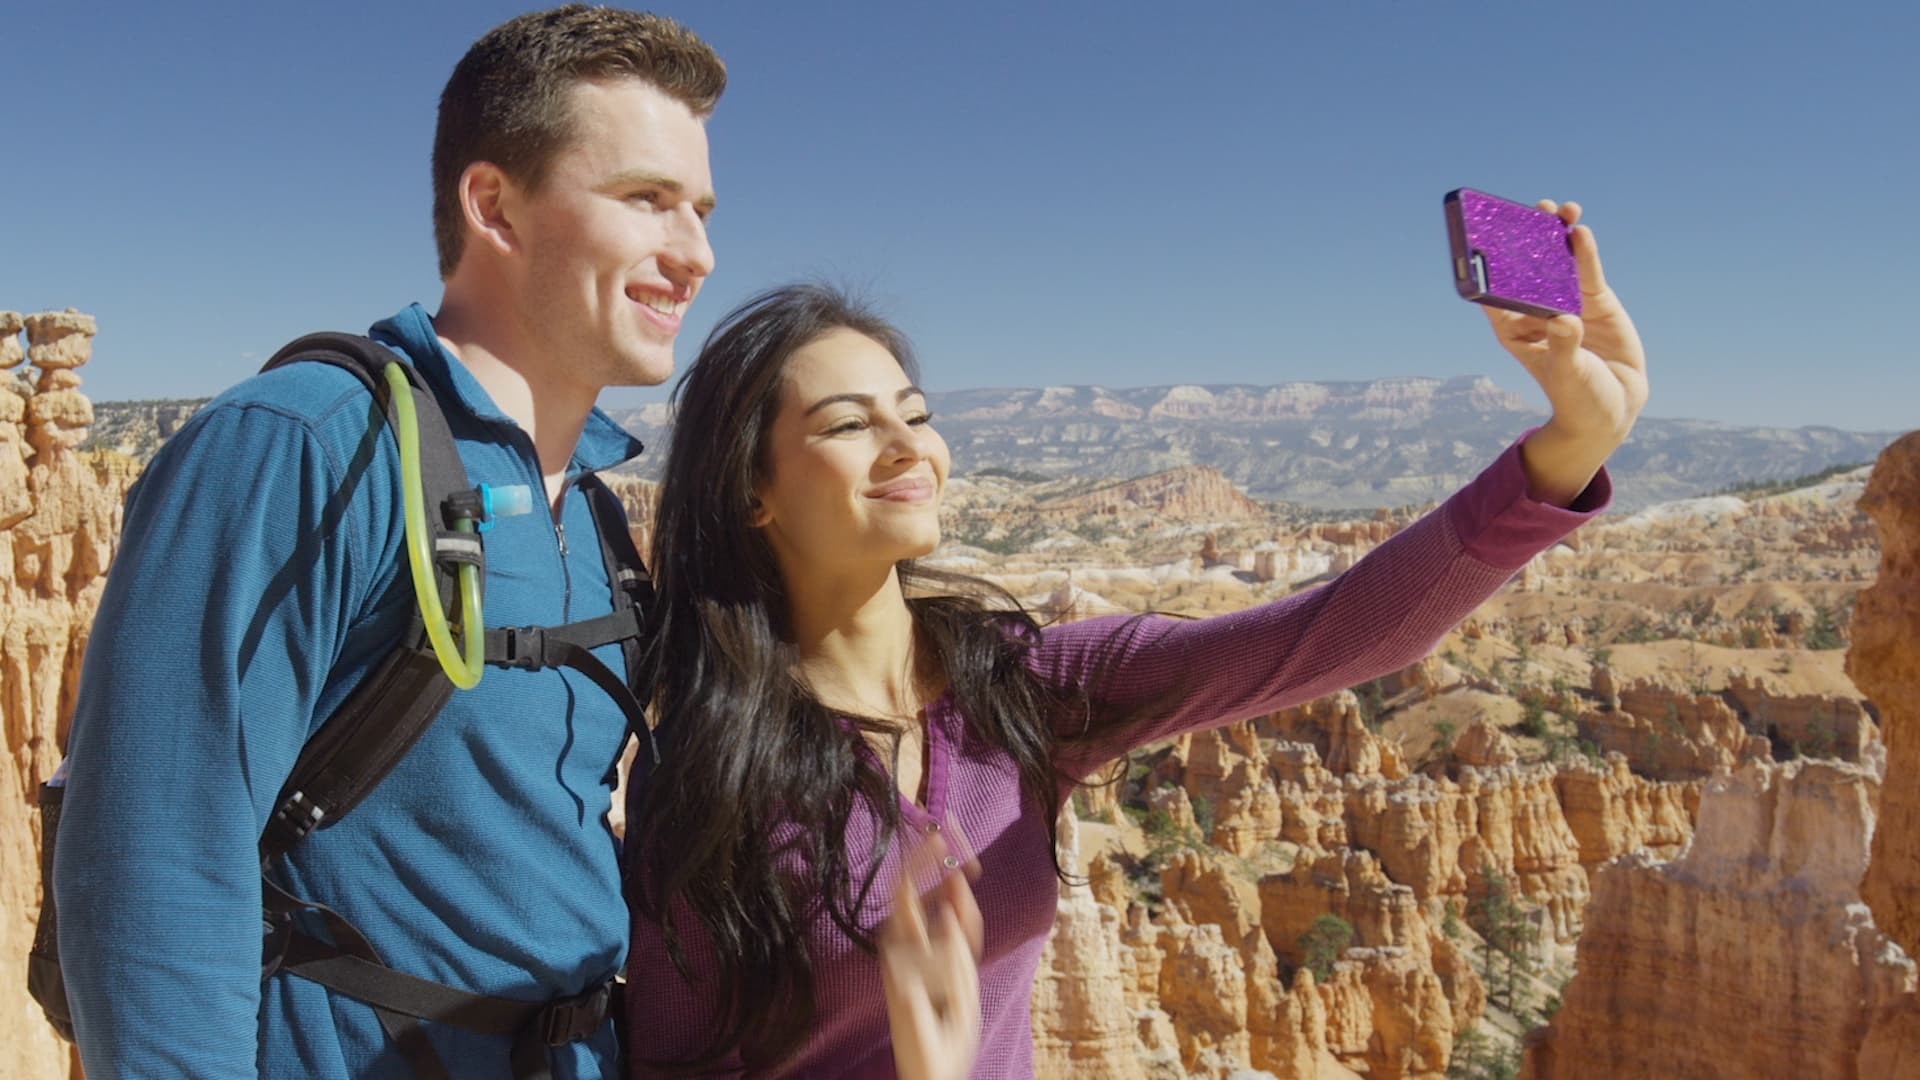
[94,377,1891,511]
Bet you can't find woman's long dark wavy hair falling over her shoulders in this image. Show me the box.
[626,284,1121,1072]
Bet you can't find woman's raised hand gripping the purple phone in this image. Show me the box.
[1486,200,1647,505]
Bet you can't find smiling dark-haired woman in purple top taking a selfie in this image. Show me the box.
[628,204,1647,1076]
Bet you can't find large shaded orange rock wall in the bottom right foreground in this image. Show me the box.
[1528,761,1916,1080]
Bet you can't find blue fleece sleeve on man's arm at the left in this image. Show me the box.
[54,404,365,1080]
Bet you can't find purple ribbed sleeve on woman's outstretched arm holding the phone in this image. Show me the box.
[1029,434,1613,780]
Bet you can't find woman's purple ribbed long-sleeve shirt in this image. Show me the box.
[626,436,1611,1078]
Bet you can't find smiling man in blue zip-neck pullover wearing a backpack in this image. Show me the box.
[54,6,726,1080]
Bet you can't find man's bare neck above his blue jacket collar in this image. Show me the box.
[434,294,599,513]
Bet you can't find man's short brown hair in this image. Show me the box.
[434,4,726,279]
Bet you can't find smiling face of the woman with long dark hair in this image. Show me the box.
[755,329,950,573]
